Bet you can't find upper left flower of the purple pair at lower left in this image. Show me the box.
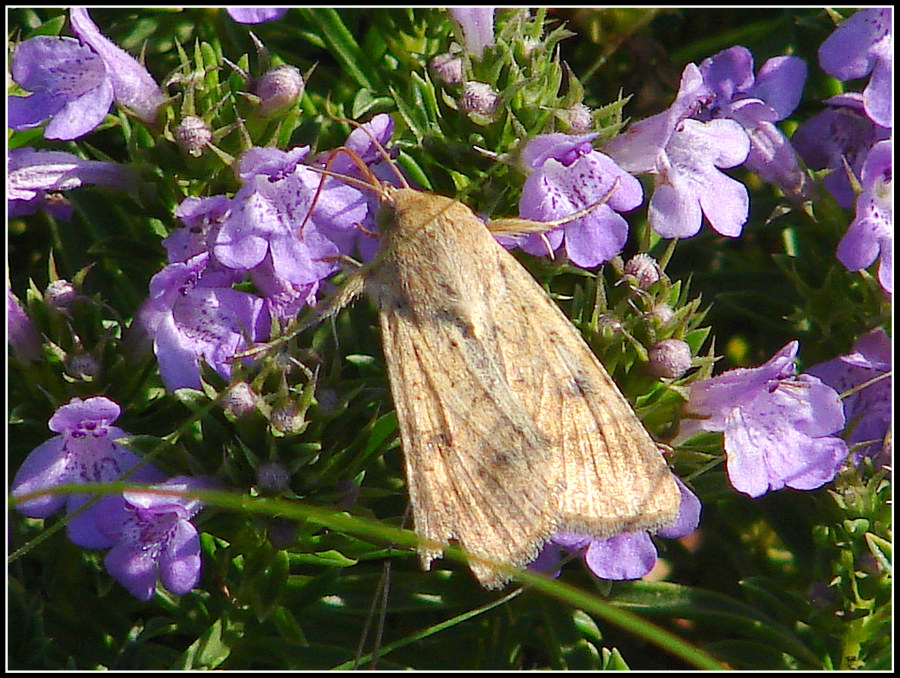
[11,396,165,548]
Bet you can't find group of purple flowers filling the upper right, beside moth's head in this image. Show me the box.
[516,9,893,292]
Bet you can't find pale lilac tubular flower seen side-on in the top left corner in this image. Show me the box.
[69,7,166,123]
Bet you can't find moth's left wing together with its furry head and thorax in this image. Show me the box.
[369,189,562,587]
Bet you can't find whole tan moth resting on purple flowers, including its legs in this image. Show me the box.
[302,127,680,589]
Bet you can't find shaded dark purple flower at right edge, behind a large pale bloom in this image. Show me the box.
[807,327,893,466]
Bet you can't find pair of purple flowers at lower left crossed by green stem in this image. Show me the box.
[10,396,205,600]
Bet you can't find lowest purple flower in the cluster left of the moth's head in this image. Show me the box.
[138,253,269,391]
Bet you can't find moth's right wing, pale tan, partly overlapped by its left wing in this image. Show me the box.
[503,278,681,537]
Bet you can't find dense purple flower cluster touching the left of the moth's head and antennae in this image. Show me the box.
[138,114,393,391]
